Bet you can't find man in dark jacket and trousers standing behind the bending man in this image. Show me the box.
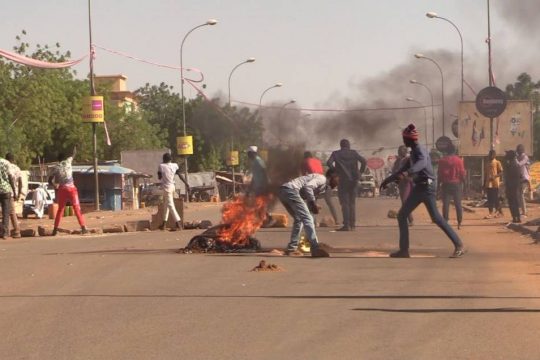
[326,139,366,231]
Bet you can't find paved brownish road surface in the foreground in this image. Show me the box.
[0,199,540,360]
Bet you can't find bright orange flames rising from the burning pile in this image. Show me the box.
[219,195,271,245]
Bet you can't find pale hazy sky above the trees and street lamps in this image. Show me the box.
[0,0,537,107]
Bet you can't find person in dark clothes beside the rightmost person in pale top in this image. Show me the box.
[503,150,523,223]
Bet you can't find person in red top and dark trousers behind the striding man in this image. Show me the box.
[437,145,466,229]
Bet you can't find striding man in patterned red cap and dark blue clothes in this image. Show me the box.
[381,124,465,258]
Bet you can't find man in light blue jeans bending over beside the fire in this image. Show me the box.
[278,170,339,257]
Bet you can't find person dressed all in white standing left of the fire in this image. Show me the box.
[158,153,190,230]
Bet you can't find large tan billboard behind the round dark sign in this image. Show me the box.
[458,100,532,156]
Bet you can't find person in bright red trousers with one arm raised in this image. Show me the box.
[49,148,88,236]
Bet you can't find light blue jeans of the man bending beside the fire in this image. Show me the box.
[278,187,319,250]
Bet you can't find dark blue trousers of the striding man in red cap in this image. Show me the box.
[398,184,463,250]
